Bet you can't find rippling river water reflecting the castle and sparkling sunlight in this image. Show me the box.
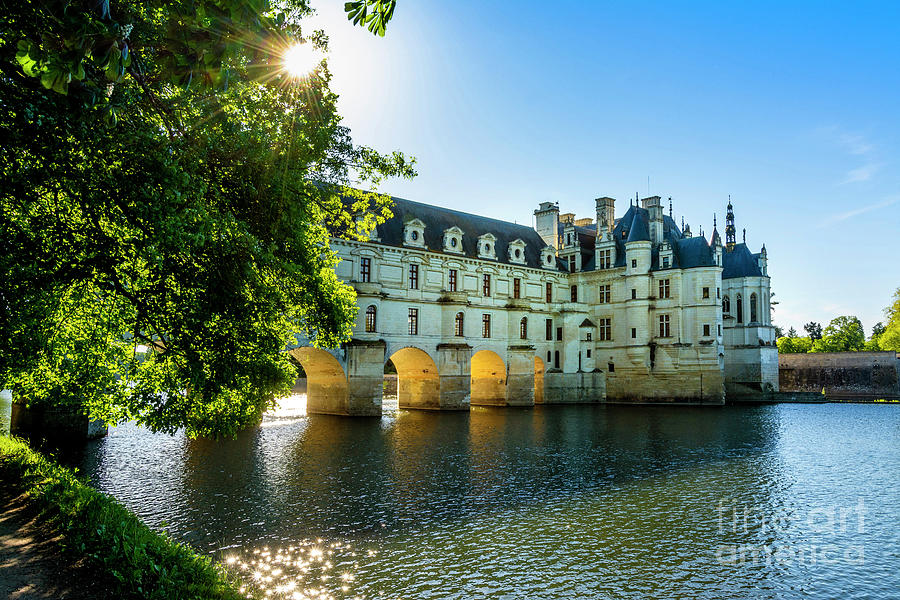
[8,396,900,599]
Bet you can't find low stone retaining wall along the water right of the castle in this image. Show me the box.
[778,352,900,400]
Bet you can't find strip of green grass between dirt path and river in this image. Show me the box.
[0,436,243,600]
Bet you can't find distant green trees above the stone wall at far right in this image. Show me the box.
[775,288,900,354]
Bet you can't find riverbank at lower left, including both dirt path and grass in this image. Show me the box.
[0,436,244,600]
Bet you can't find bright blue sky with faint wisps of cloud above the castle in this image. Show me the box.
[313,0,900,335]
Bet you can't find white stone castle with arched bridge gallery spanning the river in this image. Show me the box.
[292,196,778,414]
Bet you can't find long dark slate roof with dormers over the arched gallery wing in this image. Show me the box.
[377,198,561,269]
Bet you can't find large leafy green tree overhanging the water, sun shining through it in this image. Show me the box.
[0,0,414,436]
